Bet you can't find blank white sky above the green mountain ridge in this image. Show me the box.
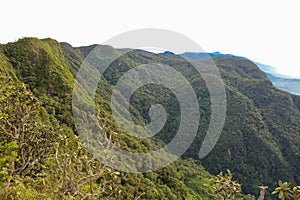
[0,0,300,77]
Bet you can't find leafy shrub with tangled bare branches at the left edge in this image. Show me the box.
[0,77,54,177]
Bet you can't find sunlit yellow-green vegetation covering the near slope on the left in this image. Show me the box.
[0,38,223,199]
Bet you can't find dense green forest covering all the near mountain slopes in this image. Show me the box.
[0,38,300,199]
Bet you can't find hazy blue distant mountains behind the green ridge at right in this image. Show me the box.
[165,51,300,95]
